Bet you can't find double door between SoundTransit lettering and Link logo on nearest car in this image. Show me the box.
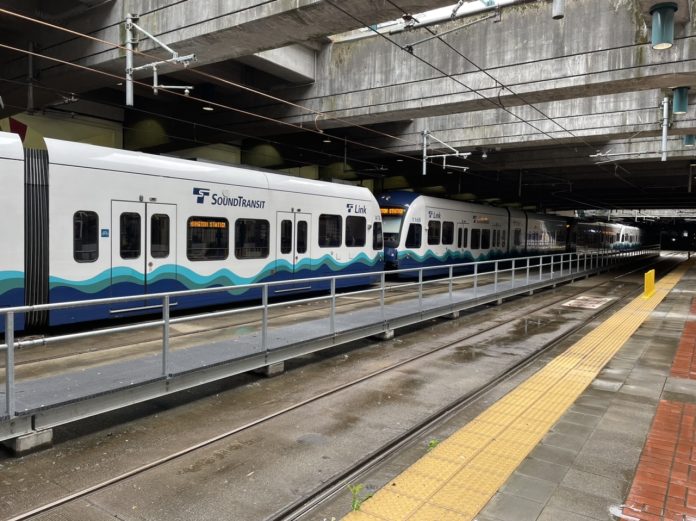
[276,212,312,282]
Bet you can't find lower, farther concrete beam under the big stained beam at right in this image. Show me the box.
[354,90,696,154]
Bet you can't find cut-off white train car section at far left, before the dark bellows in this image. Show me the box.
[0,133,24,331]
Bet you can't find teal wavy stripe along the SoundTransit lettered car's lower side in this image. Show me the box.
[49,252,379,294]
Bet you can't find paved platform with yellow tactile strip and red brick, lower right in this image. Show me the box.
[344,261,696,521]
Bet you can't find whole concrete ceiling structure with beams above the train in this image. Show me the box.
[0,0,696,210]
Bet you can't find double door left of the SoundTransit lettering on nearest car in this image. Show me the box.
[111,201,177,313]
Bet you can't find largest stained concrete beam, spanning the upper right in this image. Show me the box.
[230,0,696,132]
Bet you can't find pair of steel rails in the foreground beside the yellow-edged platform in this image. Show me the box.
[0,255,677,521]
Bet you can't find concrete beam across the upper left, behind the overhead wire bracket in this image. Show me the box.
[3,0,451,110]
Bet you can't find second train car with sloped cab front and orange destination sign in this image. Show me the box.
[378,191,571,269]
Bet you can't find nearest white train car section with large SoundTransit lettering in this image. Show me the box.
[8,134,383,325]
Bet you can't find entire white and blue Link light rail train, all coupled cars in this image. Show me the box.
[0,132,640,332]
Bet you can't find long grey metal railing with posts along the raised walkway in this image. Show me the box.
[0,249,654,418]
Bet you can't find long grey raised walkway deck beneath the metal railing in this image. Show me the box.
[0,251,620,440]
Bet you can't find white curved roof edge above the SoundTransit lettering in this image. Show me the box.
[45,139,373,200]
